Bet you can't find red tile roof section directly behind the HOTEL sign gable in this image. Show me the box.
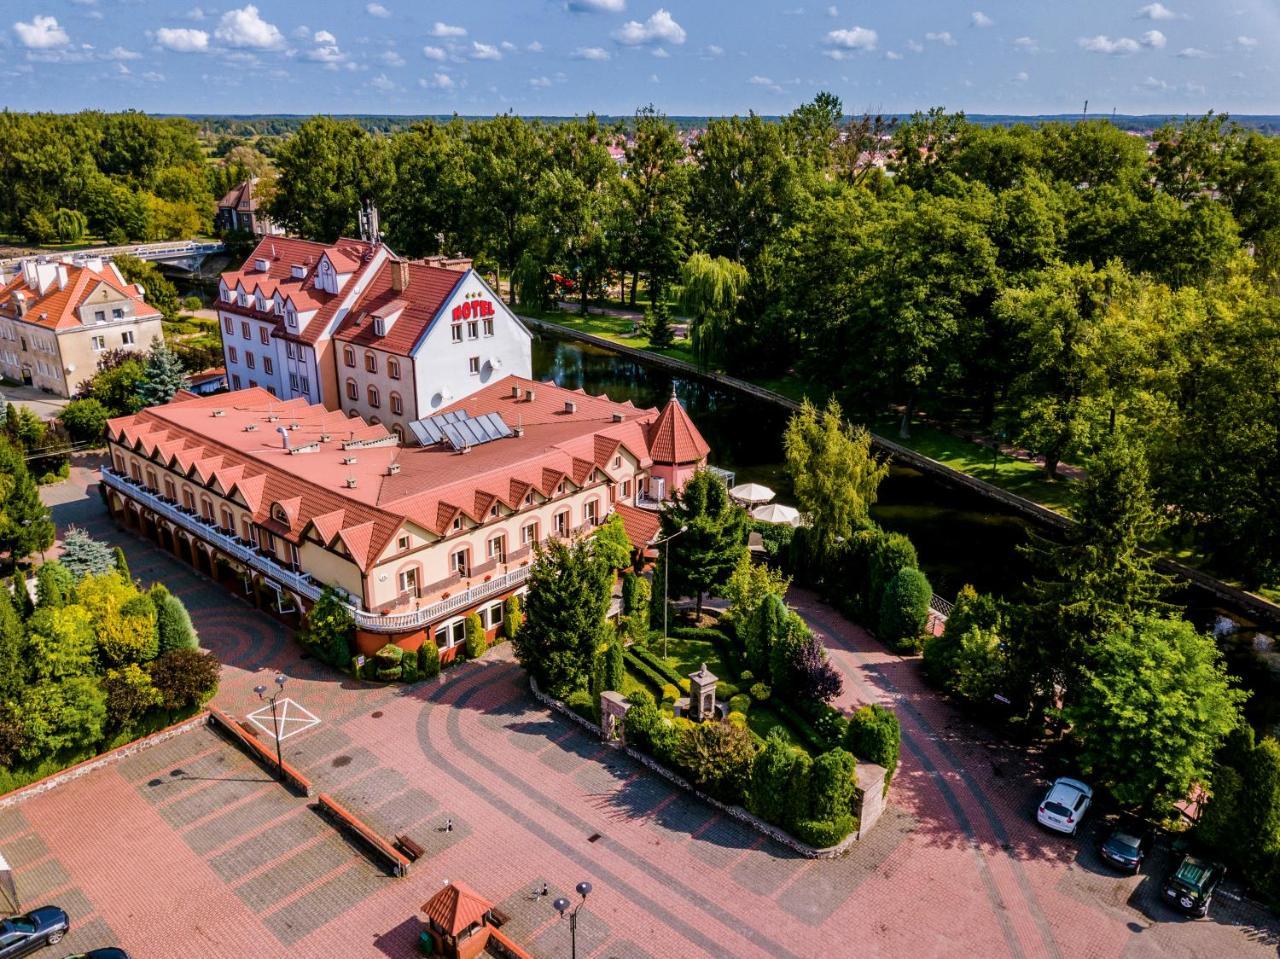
[333,262,467,356]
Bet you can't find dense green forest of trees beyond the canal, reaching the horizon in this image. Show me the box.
[0,103,1280,585]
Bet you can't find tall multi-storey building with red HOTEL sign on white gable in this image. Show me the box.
[218,237,532,432]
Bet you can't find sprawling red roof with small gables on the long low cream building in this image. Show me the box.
[108,376,700,570]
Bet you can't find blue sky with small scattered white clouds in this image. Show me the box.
[0,0,1280,114]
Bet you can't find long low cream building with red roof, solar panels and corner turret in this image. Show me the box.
[102,376,707,658]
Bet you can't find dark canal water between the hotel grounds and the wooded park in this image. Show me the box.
[534,333,1280,731]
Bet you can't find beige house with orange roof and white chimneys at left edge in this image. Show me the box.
[0,257,164,397]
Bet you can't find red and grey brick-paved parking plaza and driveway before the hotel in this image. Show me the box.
[0,460,1280,959]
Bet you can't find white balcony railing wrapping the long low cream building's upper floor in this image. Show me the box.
[101,466,529,633]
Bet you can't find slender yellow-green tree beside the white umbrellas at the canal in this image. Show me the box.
[782,398,888,556]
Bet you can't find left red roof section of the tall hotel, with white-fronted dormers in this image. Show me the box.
[218,237,375,343]
